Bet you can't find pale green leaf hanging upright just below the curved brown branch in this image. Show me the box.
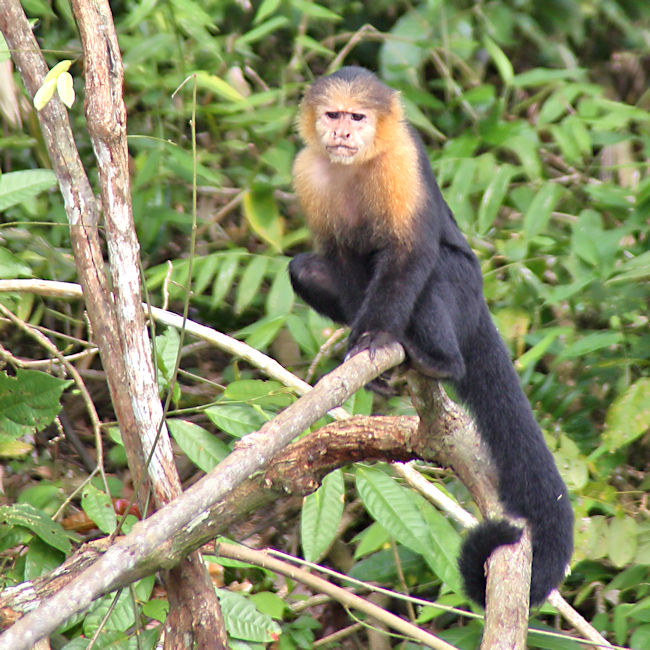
[300,469,345,562]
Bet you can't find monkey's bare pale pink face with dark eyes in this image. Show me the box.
[316,105,377,165]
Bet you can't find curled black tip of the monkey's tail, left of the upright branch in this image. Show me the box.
[458,519,522,607]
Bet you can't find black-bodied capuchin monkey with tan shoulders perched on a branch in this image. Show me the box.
[289,67,573,605]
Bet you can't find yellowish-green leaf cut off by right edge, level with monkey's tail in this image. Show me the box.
[603,377,650,451]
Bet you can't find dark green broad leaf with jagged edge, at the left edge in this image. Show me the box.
[0,368,72,438]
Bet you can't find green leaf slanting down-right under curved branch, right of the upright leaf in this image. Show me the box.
[356,467,428,555]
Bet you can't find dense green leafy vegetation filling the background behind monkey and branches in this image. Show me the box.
[0,0,650,649]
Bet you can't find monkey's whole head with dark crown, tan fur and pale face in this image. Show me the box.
[298,67,403,165]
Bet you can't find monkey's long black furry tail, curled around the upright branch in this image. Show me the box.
[456,309,573,605]
